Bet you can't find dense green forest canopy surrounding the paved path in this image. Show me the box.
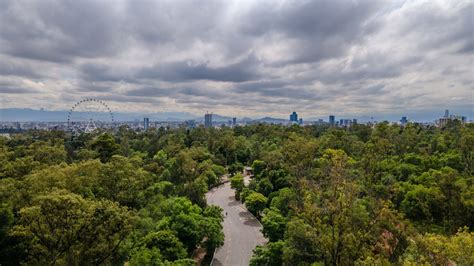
[0,123,474,265]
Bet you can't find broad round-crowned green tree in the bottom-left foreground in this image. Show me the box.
[12,190,133,265]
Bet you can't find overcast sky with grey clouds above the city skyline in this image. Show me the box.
[0,0,474,119]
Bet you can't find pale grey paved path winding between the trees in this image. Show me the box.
[206,179,266,266]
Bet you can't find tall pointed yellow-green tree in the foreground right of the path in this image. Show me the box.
[284,149,407,265]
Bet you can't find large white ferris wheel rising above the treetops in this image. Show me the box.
[67,98,114,134]
